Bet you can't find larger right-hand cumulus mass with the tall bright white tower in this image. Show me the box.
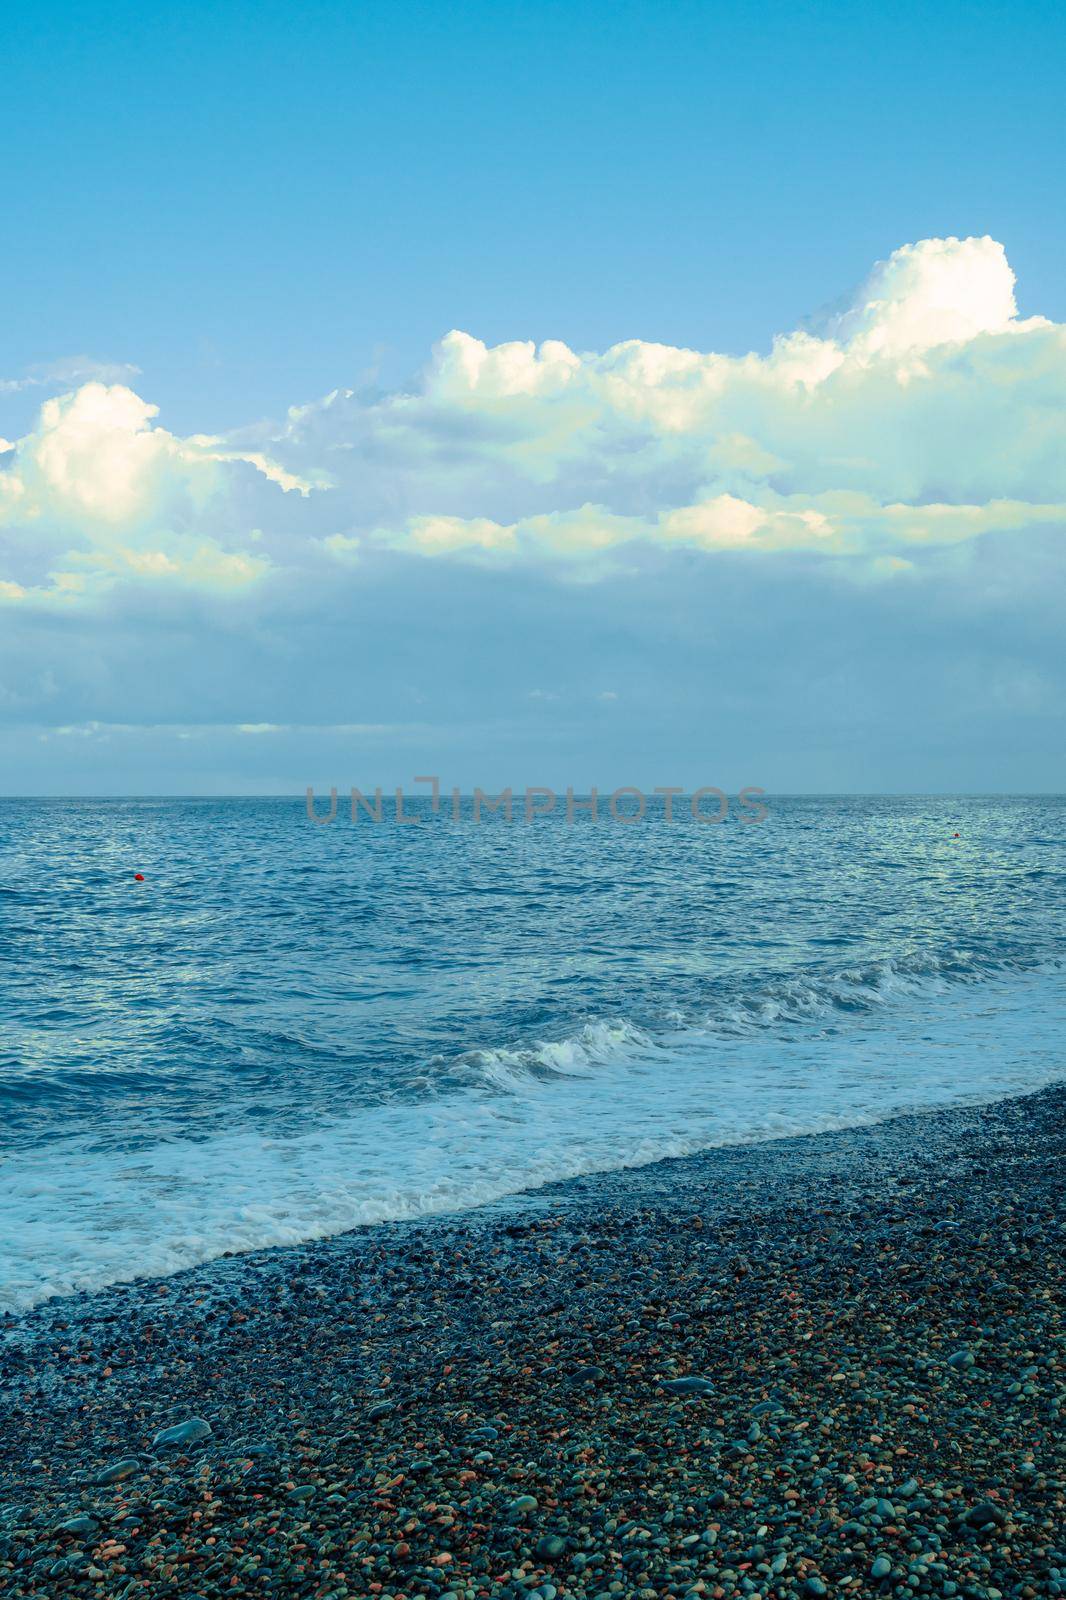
[271,238,1066,576]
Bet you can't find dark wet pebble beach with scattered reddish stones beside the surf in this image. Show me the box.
[0,1086,1066,1600]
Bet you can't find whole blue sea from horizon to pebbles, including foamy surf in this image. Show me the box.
[0,798,1066,1306]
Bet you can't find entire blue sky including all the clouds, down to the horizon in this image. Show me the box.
[0,0,1066,794]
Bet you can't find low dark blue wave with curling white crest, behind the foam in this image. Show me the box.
[0,949,1061,1136]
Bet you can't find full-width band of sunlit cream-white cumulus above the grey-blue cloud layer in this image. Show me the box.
[0,238,1066,602]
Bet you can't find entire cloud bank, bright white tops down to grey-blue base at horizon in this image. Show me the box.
[0,238,1066,792]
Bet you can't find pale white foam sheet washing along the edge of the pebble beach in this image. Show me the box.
[0,962,1063,1307]
